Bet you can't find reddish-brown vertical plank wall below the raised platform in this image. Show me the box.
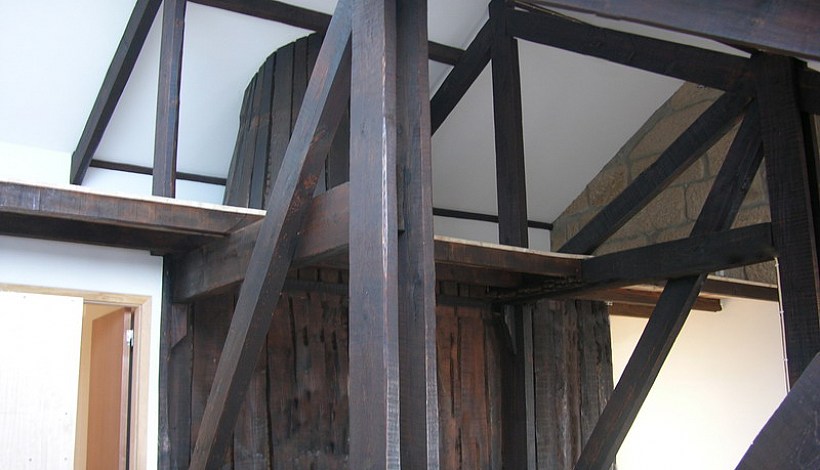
[163,280,612,470]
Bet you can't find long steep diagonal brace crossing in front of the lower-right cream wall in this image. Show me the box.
[575,101,760,470]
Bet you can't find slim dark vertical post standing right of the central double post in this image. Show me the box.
[490,0,536,469]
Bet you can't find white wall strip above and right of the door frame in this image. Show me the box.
[0,236,162,469]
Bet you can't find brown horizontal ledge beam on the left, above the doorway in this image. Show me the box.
[0,182,262,253]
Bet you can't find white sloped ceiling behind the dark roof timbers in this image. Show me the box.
[0,0,772,221]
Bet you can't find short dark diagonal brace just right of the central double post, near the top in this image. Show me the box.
[430,21,493,134]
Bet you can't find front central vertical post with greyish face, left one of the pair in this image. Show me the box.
[349,0,401,469]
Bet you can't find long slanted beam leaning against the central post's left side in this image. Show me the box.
[190,0,351,469]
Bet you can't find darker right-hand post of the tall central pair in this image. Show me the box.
[398,0,442,469]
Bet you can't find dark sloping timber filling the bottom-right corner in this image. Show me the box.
[737,355,820,470]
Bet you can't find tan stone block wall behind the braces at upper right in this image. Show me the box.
[552,83,776,283]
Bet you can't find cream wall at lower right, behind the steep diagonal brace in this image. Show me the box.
[611,300,787,470]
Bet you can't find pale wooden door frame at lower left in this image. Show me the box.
[0,283,156,468]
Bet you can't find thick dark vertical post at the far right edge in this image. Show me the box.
[753,54,820,384]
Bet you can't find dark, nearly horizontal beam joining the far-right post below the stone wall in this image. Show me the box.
[581,223,777,289]
